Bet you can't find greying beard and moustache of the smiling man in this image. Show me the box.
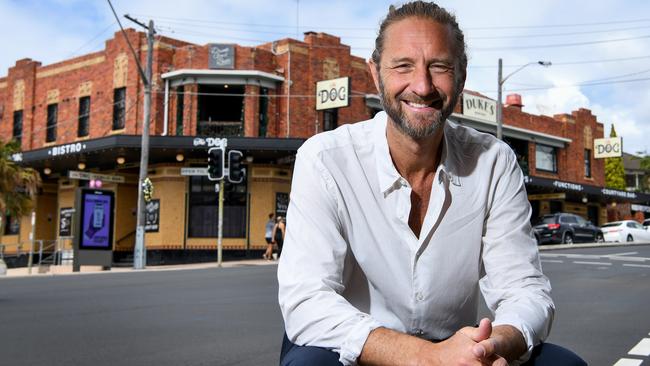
[379,76,458,139]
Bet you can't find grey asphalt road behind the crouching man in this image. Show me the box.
[0,246,650,366]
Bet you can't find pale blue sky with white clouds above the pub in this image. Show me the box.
[0,0,650,154]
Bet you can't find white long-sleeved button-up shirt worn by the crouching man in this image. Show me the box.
[278,112,554,365]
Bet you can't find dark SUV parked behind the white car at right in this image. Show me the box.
[533,213,604,244]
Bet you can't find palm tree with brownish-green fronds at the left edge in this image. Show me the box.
[0,140,41,235]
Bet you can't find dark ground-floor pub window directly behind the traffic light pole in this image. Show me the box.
[188,176,247,238]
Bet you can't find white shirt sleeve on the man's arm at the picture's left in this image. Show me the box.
[278,141,380,365]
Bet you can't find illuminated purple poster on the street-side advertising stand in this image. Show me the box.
[81,192,112,249]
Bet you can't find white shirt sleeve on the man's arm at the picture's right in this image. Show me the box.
[480,148,555,362]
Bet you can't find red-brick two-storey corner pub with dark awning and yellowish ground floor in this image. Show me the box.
[0,29,650,265]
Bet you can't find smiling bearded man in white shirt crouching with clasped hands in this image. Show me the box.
[278,1,583,365]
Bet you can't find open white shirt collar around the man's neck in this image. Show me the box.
[373,112,461,196]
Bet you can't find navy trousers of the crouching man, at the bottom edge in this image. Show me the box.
[280,334,587,366]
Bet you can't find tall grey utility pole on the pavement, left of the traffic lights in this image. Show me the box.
[133,20,154,269]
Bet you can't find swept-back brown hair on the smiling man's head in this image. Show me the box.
[372,1,467,86]
